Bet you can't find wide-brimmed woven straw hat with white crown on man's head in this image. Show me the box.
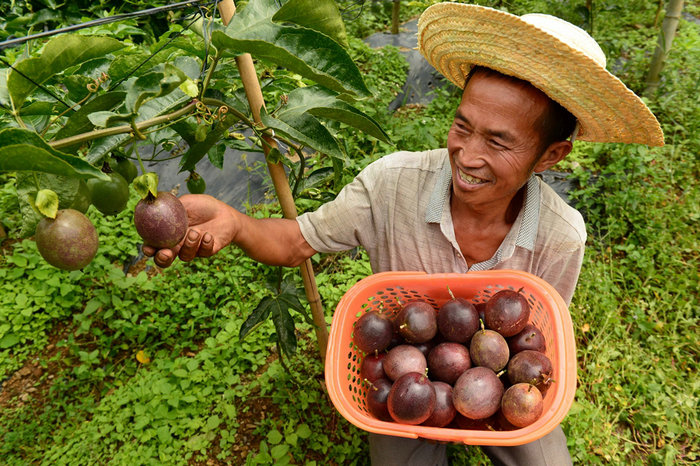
[418,3,664,146]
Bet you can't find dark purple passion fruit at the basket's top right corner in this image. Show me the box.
[484,290,530,337]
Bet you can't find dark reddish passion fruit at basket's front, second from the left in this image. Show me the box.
[387,372,435,424]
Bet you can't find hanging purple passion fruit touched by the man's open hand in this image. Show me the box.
[134,191,188,248]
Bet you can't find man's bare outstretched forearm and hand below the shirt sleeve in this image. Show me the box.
[143,194,316,267]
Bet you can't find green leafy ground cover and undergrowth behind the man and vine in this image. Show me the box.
[0,0,700,464]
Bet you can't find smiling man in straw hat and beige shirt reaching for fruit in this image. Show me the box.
[144,3,663,465]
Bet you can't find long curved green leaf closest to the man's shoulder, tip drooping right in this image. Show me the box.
[277,86,389,142]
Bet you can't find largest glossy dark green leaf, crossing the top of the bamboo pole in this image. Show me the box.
[212,0,370,96]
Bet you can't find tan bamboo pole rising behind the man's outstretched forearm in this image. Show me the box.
[218,0,328,363]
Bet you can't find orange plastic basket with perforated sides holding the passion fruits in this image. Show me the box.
[325,270,576,445]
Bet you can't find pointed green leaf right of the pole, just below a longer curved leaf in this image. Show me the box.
[260,113,345,159]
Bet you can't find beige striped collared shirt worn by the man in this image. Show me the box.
[297,149,586,304]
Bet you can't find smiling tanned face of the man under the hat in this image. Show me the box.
[447,73,547,208]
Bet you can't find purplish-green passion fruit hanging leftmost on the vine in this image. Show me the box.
[34,209,99,270]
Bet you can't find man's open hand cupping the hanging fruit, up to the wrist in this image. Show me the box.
[143,194,238,267]
